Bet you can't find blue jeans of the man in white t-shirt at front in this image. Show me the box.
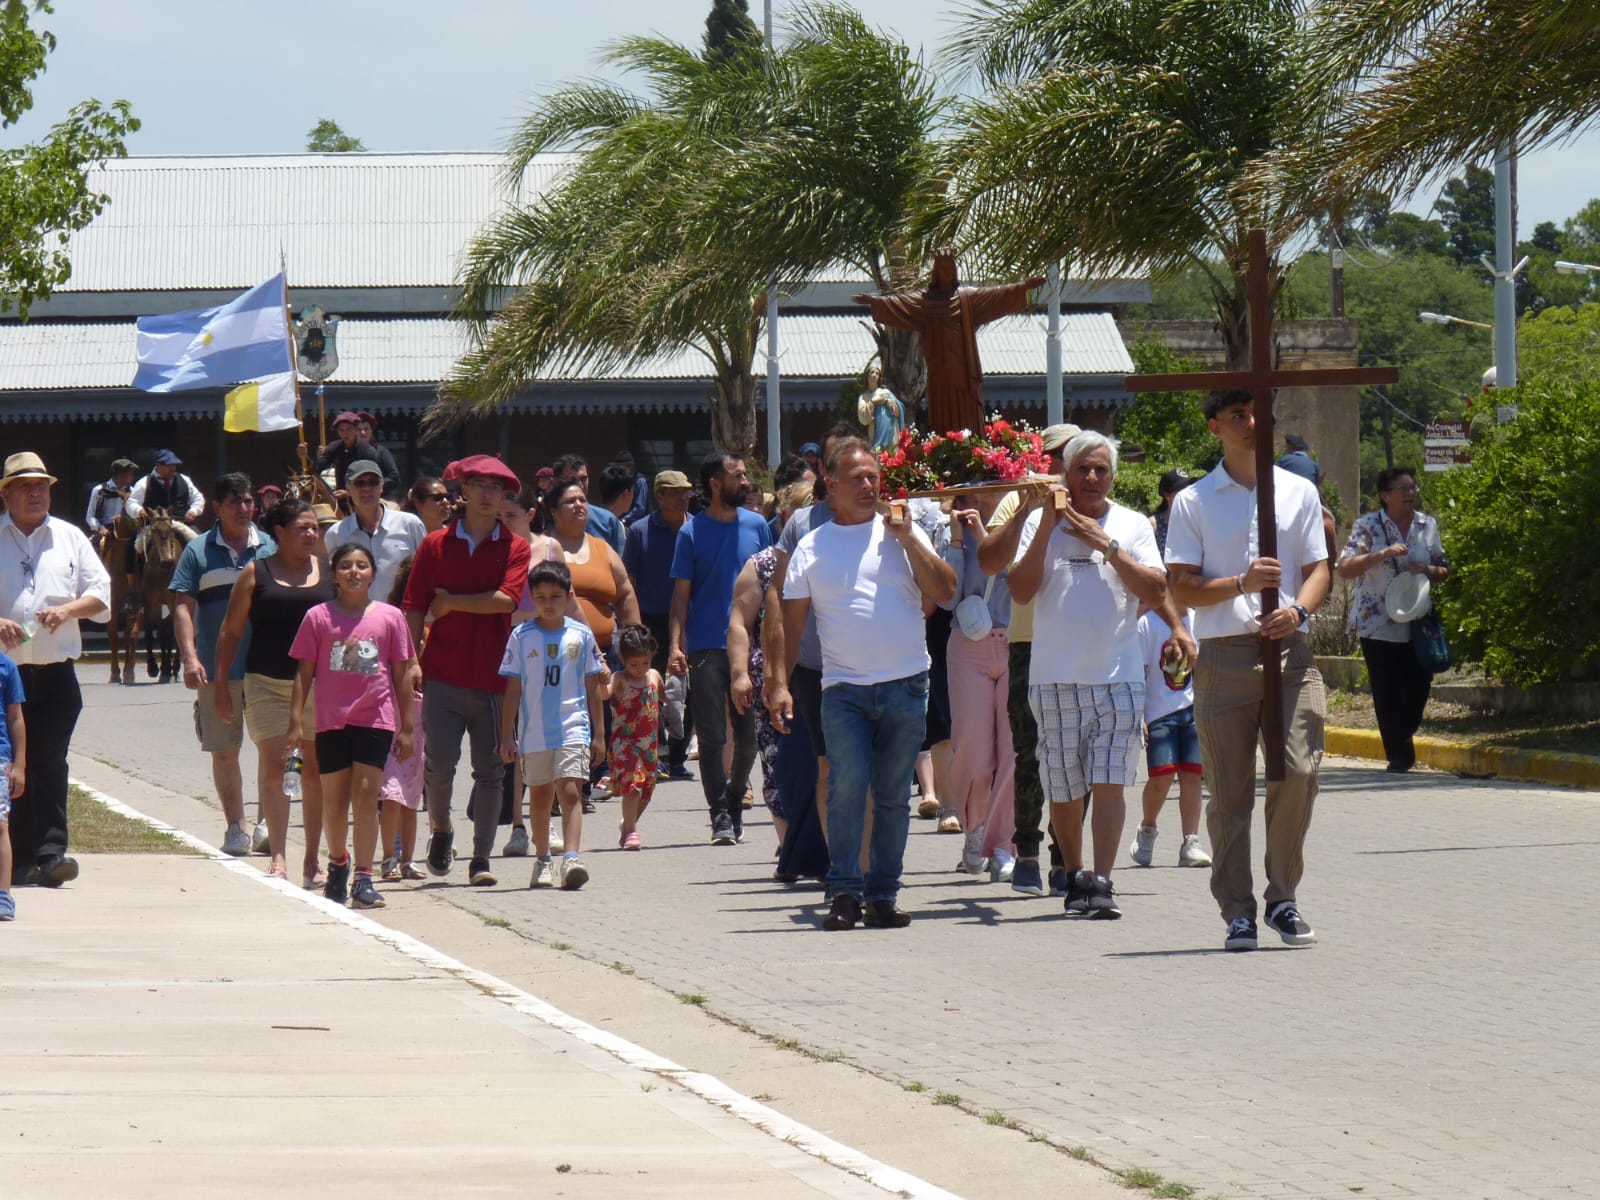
[822,670,928,901]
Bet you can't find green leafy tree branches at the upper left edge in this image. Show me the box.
[0,0,139,320]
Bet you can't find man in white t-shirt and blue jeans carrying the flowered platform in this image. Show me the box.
[774,438,955,930]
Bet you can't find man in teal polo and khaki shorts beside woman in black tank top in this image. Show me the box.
[173,472,277,854]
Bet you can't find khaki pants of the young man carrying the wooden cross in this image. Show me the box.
[1195,634,1328,922]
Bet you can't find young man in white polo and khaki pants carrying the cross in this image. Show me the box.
[1166,392,1333,950]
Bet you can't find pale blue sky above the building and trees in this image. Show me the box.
[12,0,1600,237]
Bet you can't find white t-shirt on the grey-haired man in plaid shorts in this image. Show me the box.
[1011,501,1162,685]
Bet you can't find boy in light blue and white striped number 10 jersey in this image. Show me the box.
[499,562,606,891]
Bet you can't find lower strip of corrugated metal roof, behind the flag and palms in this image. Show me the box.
[0,312,1133,390]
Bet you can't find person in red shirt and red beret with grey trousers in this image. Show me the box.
[402,454,531,888]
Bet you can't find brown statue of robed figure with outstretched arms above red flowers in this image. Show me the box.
[851,250,1045,434]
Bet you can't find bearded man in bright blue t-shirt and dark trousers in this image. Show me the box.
[667,451,771,846]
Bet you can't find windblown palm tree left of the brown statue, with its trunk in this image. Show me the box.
[429,6,939,453]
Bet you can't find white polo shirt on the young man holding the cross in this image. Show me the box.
[1166,462,1328,640]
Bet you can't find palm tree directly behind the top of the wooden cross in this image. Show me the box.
[931,0,1326,366]
